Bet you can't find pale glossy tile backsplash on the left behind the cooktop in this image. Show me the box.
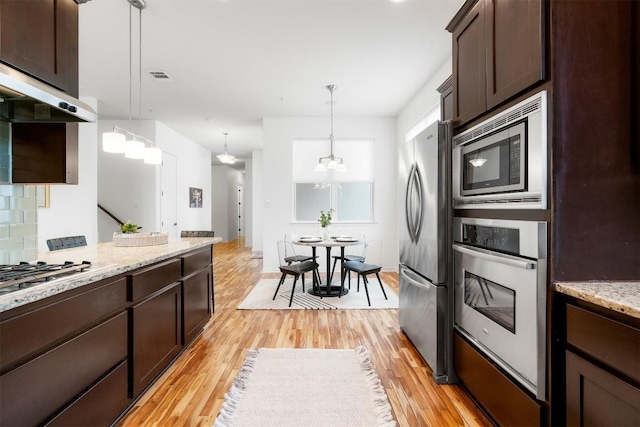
[0,185,38,264]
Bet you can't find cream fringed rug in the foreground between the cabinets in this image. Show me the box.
[214,346,397,427]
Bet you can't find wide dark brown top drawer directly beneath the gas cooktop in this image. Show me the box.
[0,278,127,371]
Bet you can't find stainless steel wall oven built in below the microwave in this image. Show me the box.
[453,218,547,400]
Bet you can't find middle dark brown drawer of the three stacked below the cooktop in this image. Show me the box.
[0,312,127,426]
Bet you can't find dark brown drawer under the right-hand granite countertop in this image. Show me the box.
[567,305,640,381]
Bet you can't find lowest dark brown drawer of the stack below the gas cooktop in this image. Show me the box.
[46,360,130,426]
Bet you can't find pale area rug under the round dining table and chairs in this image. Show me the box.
[238,279,398,310]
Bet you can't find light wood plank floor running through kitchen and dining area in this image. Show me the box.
[119,240,491,427]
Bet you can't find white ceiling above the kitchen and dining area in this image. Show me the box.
[79,0,464,167]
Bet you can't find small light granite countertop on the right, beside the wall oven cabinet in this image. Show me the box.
[554,281,640,319]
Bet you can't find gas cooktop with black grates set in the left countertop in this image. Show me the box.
[0,261,91,294]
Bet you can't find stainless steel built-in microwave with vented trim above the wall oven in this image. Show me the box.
[452,91,547,209]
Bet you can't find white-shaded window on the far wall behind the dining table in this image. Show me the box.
[292,139,374,223]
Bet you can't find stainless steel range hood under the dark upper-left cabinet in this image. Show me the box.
[0,64,97,123]
